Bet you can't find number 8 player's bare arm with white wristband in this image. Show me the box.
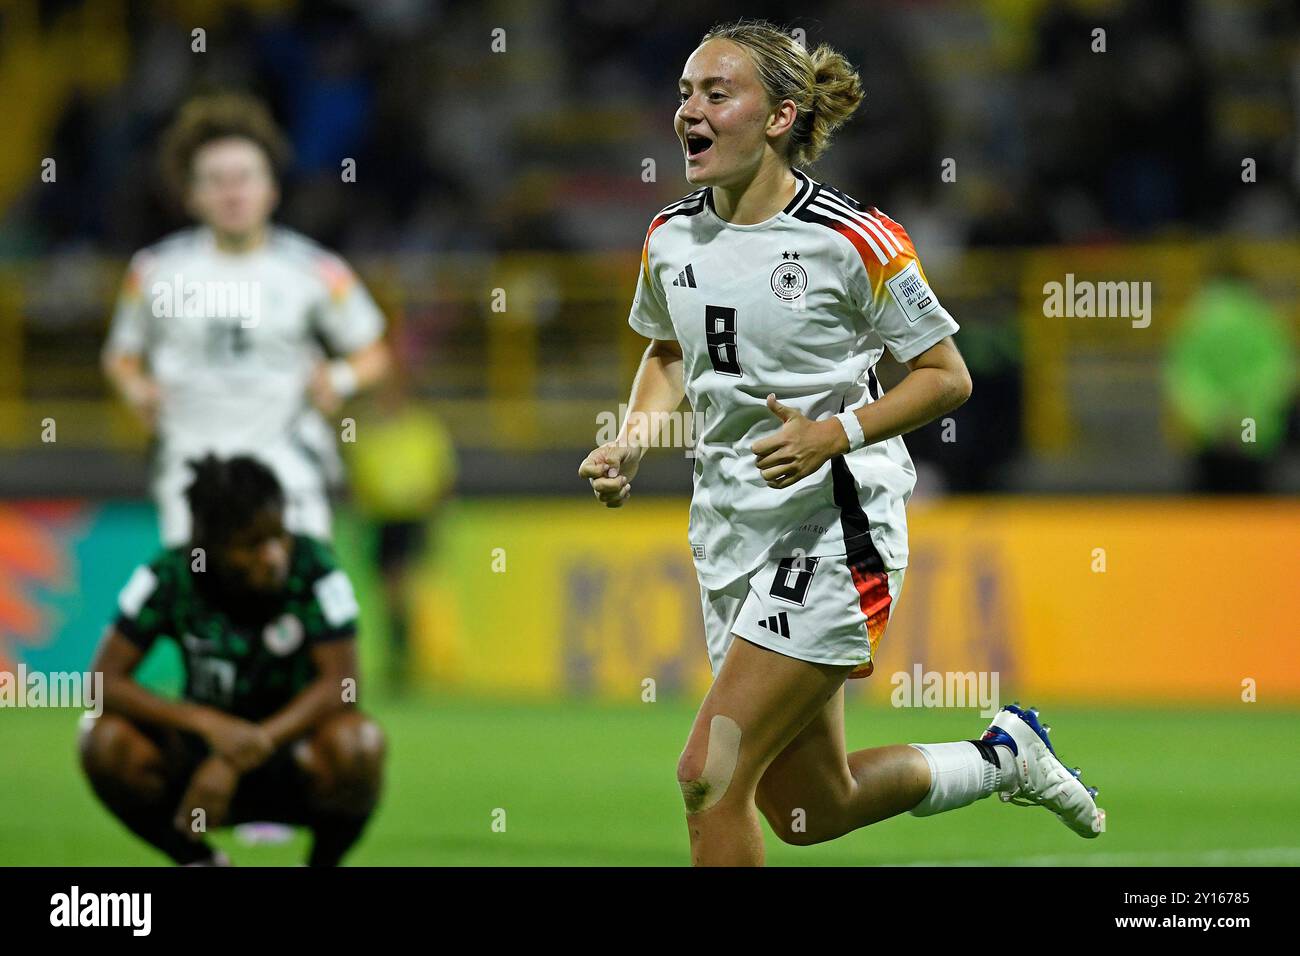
[753,336,971,488]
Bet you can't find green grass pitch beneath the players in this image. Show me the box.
[0,696,1300,866]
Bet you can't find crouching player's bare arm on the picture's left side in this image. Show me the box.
[91,631,274,771]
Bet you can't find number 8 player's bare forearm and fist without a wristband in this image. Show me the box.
[577,338,686,507]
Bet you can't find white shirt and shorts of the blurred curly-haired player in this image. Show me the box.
[105,226,384,545]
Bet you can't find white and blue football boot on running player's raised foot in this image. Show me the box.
[980,704,1106,839]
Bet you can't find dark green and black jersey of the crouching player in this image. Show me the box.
[114,535,358,721]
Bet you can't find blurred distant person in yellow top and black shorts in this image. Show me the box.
[343,362,456,691]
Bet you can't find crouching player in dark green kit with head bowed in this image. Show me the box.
[81,455,385,866]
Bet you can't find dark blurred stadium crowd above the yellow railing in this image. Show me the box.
[0,0,1300,490]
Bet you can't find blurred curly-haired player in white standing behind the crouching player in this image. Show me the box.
[103,94,389,545]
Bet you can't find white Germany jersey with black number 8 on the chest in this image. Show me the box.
[628,170,958,589]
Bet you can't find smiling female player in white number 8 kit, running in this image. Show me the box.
[579,21,1104,865]
